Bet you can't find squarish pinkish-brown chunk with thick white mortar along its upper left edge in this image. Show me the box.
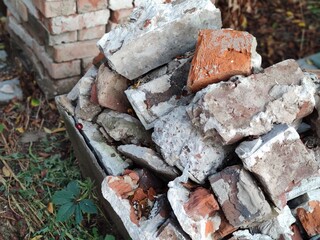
[236,125,319,209]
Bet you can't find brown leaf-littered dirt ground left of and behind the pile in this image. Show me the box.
[0,0,320,240]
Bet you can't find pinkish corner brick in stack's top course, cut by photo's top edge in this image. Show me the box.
[33,0,76,18]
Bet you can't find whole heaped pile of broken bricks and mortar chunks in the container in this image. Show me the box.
[56,0,320,240]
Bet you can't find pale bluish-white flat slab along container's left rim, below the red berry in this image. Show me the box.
[78,119,129,175]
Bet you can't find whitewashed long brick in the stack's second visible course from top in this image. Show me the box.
[42,9,110,34]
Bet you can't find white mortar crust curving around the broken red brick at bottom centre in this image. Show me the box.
[168,171,221,240]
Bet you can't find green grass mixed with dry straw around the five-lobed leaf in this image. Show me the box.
[0,133,114,240]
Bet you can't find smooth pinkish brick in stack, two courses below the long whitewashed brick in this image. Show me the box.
[52,40,99,62]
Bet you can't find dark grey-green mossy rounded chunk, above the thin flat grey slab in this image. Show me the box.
[97,109,151,146]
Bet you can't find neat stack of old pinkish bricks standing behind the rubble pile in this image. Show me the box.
[4,0,134,98]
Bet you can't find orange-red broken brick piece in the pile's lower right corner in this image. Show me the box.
[297,201,320,237]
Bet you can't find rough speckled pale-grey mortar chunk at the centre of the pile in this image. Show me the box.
[152,106,233,183]
